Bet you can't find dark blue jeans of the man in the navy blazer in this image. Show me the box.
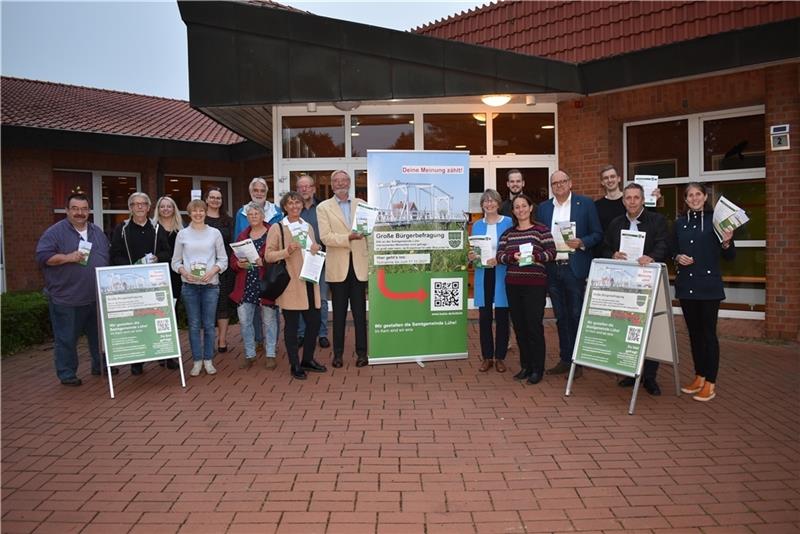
[547,263,586,363]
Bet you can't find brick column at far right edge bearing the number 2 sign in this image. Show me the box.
[764,65,800,341]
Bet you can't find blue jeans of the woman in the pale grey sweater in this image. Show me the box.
[181,283,219,362]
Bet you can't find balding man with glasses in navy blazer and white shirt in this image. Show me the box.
[536,170,603,378]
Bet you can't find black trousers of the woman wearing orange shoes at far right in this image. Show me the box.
[681,299,720,384]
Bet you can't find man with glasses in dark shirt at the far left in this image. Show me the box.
[36,193,112,386]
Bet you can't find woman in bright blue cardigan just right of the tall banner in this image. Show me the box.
[469,189,513,373]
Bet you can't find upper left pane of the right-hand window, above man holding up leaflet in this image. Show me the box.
[626,119,689,180]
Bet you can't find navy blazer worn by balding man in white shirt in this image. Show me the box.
[536,193,603,280]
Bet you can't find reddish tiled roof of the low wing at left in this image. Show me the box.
[0,76,245,145]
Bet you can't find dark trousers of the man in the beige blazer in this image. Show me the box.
[330,257,367,358]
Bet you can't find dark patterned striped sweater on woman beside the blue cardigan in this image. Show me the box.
[497,222,556,286]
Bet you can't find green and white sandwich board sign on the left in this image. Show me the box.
[95,263,186,399]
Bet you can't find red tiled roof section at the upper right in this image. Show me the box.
[413,1,800,63]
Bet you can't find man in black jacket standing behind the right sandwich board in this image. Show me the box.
[603,183,670,395]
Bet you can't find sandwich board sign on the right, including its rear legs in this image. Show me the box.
[565,259,680,414]
